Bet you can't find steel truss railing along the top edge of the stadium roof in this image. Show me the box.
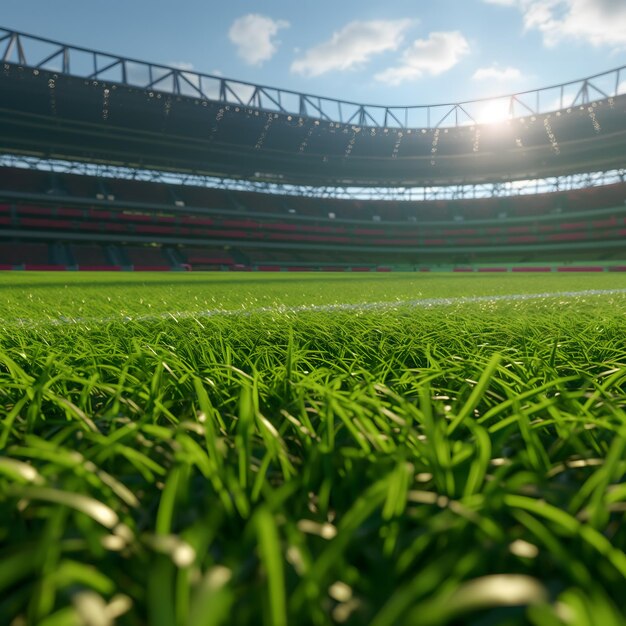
[0,27,626,129]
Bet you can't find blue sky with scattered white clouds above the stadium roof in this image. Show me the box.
[0,0,626,105]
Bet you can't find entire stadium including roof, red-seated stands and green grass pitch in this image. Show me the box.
[0,14,626,626]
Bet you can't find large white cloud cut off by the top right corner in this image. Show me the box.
[484,0,626,48]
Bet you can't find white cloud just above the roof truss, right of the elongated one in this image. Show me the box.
[375,31,470,85]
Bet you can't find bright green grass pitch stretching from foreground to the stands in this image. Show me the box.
[0,273,626,626]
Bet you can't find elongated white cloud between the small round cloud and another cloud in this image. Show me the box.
[291,19,413,76]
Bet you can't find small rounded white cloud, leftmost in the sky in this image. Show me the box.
[228,13,289,65]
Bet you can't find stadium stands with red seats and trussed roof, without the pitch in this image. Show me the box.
[0,29,626,271]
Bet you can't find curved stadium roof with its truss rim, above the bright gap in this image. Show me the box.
[0,29,626,186]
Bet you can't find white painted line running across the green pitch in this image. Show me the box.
[0,289,626,328]
